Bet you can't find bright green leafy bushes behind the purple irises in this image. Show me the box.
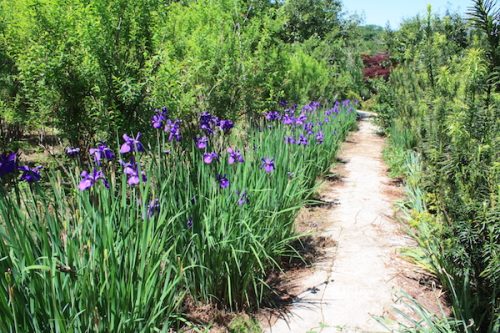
[0,0,362,149]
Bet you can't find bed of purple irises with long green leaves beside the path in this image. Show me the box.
[0,101,356,332]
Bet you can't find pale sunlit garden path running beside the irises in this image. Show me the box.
[266,113,442,333]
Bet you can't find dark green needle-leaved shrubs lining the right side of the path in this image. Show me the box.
[377,1,500,332]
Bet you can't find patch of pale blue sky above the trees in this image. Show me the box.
[342,0,472,28]
